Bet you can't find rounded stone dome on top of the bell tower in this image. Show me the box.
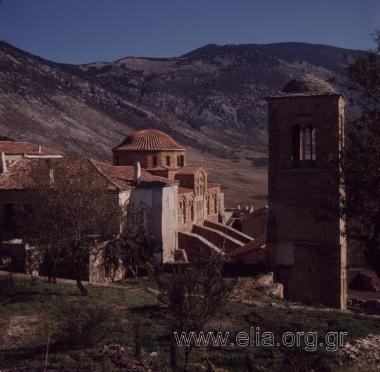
[282,75,336,95]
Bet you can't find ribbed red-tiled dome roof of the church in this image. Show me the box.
[114,129,184,151]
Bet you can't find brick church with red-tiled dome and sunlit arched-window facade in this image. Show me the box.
[112,129,224,231]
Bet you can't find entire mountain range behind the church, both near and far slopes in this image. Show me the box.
[0,42,361,206]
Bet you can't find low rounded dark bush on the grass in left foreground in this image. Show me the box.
[54,299,120,349]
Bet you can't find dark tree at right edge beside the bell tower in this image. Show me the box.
[343,30,380,276]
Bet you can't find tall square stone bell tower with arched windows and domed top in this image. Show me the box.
[267,75,347,309]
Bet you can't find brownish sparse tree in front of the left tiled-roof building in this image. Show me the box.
[24,159,121,295]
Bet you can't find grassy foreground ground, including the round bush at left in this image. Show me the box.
[0,277,380,371]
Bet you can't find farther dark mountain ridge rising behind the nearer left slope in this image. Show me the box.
[74,43,358,153]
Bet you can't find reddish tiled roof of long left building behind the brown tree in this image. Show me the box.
[0,158,174,191]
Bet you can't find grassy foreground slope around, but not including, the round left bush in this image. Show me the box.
[0,280,380,371]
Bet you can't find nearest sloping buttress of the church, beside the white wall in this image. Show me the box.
[178,232,224,262]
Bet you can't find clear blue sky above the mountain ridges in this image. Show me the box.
[0,0,380,63]
